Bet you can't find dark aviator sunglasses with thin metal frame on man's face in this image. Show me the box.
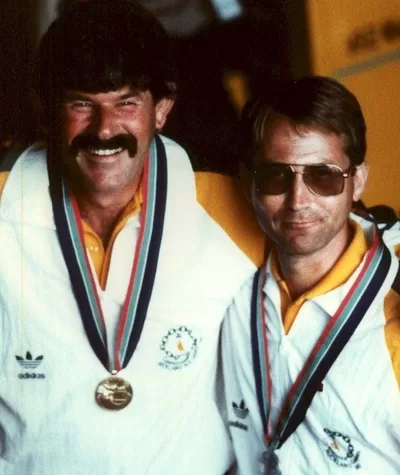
[253,162,357,196]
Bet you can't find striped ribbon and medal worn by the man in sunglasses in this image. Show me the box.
[251,230,391,475]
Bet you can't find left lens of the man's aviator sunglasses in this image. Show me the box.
[254,165,293,195]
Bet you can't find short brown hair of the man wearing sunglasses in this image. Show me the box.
[242,76,367,165]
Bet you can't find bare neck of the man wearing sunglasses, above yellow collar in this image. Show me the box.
[277,226,354,301]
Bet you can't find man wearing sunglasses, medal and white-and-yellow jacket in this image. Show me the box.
[223,77,400,475]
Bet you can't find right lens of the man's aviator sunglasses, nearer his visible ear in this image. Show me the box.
[304,165,344,196]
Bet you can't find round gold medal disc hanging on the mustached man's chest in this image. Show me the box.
[96,376,133,410]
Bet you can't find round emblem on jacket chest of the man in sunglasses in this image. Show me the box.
[324,429,361,470]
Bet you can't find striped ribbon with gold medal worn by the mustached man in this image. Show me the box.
[48,136,167,409]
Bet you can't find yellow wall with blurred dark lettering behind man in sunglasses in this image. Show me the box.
[307,0,400,214]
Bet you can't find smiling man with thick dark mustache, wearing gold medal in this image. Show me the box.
[0,0,264,475]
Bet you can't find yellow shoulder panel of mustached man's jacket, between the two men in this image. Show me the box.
[195,172,265,267]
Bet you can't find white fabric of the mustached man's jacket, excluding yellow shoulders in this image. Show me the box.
[0,138,266,475]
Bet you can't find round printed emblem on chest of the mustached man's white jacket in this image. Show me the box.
[158,326,200,370]
